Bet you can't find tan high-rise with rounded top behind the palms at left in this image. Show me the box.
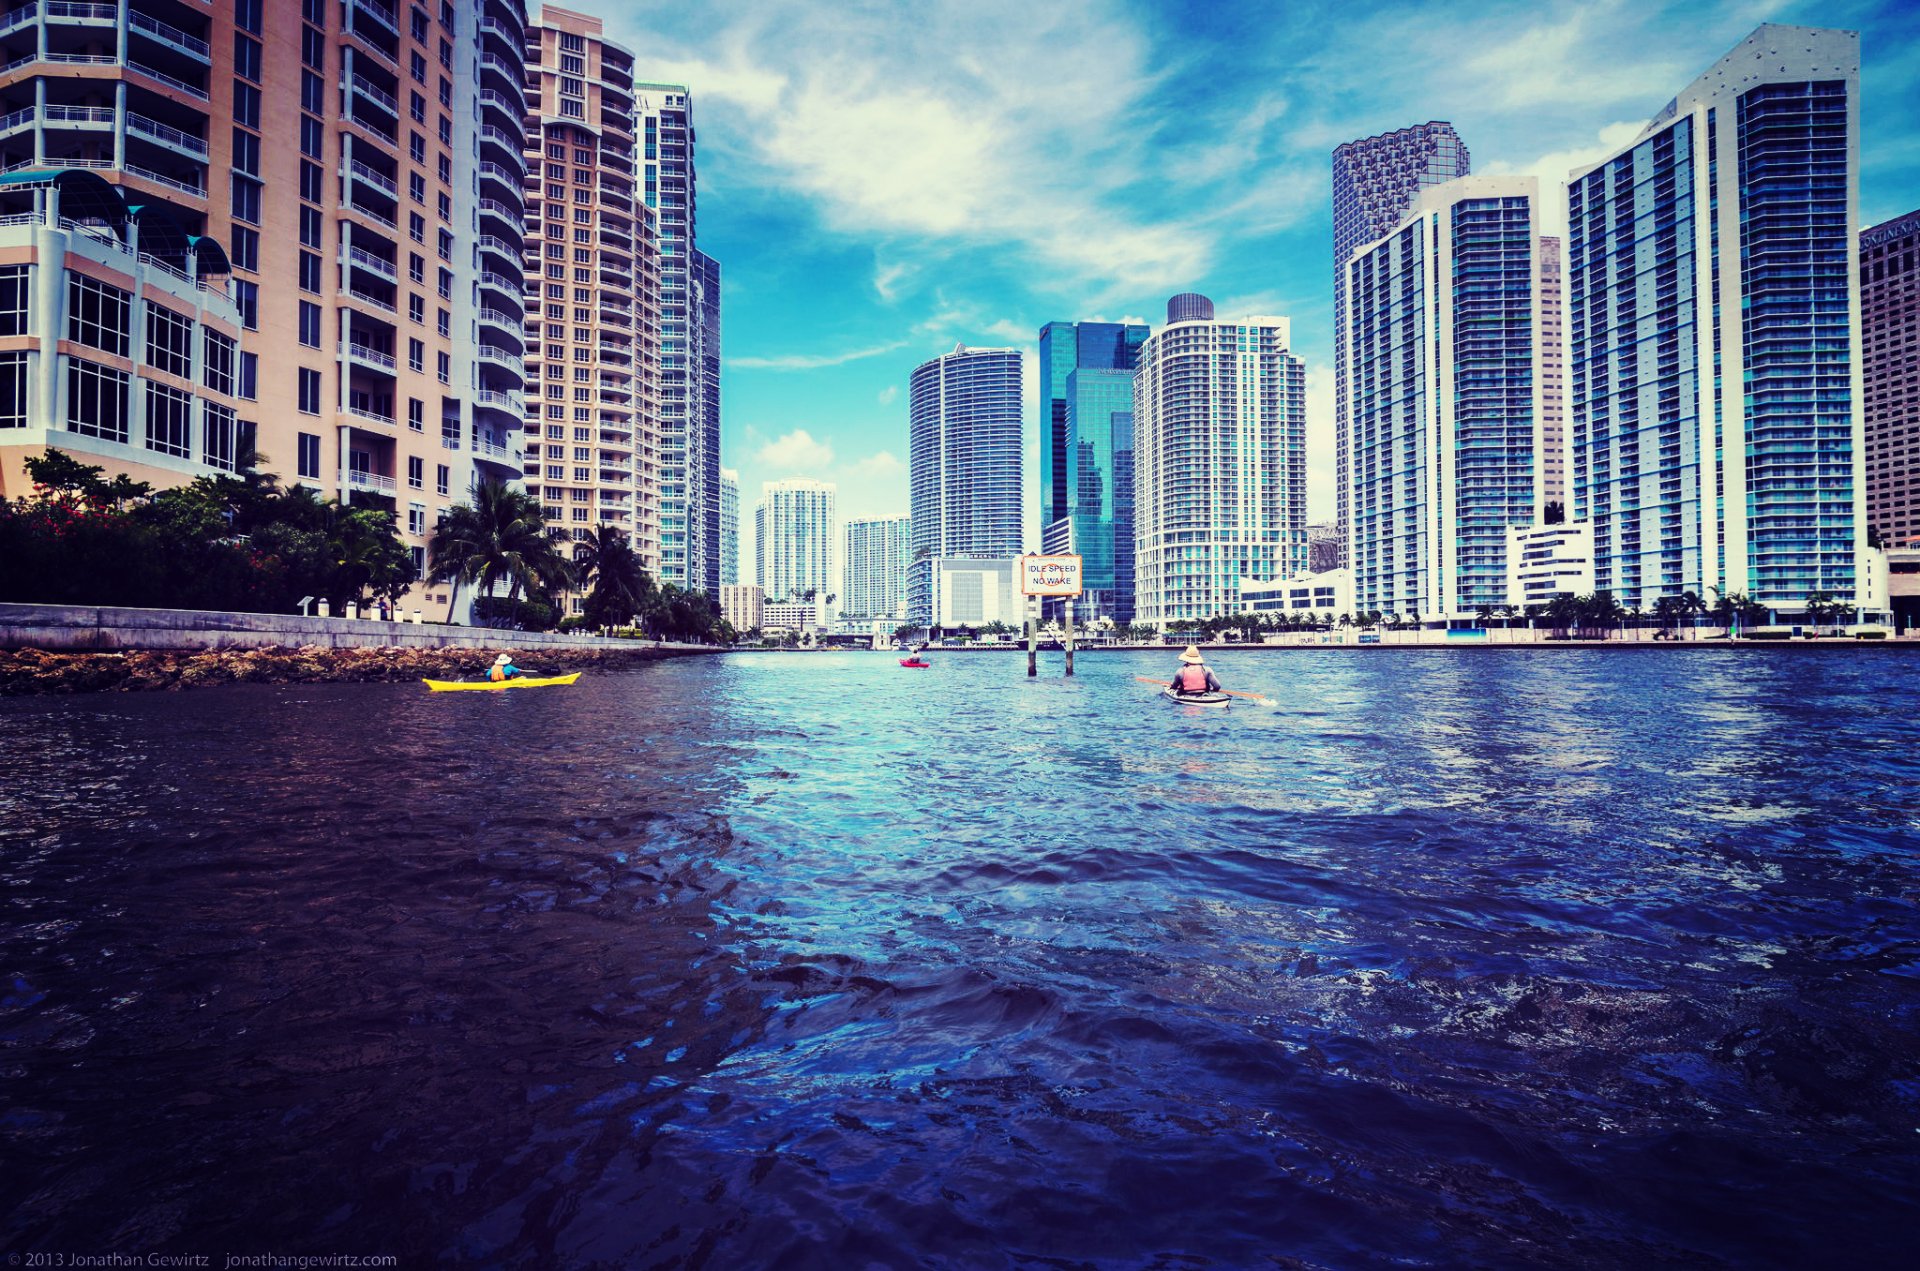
[522,6,660,591]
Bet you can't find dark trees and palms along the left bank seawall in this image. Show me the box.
[0,449,733,643]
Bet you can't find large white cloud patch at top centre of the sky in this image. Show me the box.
[614,0,1217,300]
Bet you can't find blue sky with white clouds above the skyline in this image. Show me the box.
[599,0,1920,564]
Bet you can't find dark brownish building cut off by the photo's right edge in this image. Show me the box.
[1860,211,1920,547]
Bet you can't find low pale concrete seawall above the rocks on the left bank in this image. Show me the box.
[0,605,718,655]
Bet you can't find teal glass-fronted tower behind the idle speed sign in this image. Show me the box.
[1039,323,1148,622]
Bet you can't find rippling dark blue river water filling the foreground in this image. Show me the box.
[0,649,1920,1269]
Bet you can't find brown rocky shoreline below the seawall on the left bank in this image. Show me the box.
[0,641,698,697]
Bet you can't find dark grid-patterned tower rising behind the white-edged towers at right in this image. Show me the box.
[1332,121,1473,564]
